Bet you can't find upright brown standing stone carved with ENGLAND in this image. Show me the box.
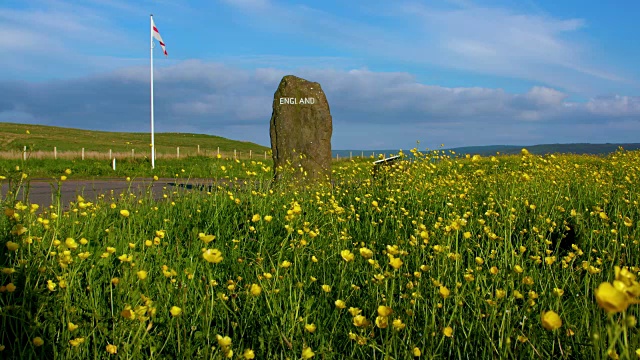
[270,75,333,182]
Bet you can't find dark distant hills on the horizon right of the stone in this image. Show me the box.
[332,143,640,159]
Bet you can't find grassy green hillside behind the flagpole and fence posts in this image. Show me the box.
[0,123,269,154]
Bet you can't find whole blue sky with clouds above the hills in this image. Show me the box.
[0,0,640,150]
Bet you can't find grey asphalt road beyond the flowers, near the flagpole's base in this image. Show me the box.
[1,179,218,208]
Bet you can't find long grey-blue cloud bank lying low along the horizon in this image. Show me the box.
[0,61,640,149]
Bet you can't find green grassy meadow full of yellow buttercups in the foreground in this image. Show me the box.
[0,151,640,359]
